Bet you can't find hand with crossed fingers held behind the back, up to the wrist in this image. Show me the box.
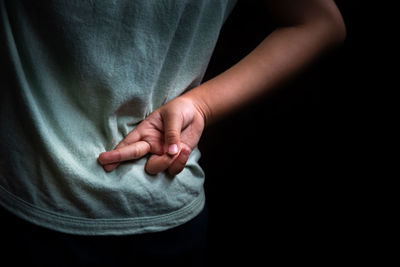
[98,96,205,175]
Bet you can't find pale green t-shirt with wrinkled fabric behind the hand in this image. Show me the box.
[0,0,235,235]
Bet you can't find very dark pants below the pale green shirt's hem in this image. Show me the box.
[0,208,207,266]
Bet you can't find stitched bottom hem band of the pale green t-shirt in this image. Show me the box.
[0,186,205,235]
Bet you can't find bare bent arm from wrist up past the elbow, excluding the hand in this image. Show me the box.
[184,0,346,123]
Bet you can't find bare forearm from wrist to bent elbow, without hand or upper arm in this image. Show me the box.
[185,5,344,123]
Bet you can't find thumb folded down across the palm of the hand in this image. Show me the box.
[163,109,182,156]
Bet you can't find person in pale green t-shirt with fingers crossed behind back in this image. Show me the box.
[0,0,346,266]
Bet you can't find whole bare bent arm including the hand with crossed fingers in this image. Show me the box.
[99,0,346,175]
